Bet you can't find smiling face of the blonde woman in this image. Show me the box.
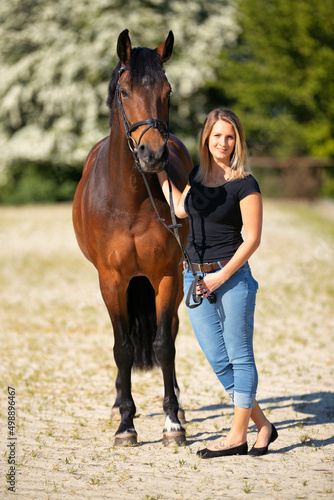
[208,120,235,166]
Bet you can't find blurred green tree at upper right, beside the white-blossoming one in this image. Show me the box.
[208,0,334,157]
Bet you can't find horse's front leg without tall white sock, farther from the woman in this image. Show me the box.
[100,274,137,446]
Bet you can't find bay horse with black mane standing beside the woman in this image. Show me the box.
[73,30,192,446]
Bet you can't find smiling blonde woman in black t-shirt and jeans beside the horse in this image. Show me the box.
[158,109,277,458]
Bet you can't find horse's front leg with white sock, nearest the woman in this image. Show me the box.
[153,276,186,446]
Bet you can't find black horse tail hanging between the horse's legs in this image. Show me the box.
[127,276,157,370]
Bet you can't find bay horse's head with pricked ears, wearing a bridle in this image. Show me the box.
[107,30,174,173]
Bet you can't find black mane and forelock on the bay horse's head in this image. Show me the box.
[107,47,165,127]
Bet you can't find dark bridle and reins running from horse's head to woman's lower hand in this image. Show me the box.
[116,67,203,309]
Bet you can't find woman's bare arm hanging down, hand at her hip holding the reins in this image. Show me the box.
[197,192,262,297]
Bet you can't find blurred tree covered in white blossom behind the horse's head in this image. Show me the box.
[0,0,238,202]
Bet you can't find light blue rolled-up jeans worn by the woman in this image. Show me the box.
[183,263,258,408]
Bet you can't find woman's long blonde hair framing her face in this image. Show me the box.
[196,109,250,184]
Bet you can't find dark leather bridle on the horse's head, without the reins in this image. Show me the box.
[115,66,169,172]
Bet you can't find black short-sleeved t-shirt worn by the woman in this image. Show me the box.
[184,166,261,264]
